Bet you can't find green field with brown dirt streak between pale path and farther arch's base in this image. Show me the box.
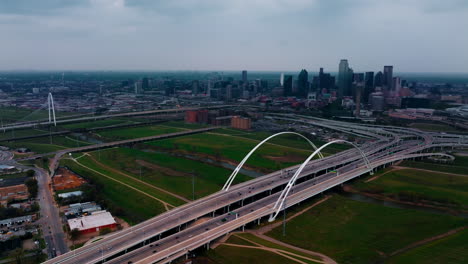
[86,148,251,199]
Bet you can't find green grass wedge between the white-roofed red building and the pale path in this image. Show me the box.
[60,159,166,224]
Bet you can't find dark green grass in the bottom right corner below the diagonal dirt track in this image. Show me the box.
[387,229,468,264]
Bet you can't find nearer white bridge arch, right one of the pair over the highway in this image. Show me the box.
[268,139,373,222]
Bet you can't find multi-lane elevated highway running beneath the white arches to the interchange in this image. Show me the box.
[38,118,468,263]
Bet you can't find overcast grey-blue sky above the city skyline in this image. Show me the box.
[0,0,468,73]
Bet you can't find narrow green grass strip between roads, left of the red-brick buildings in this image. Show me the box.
[99,125,183,140]
